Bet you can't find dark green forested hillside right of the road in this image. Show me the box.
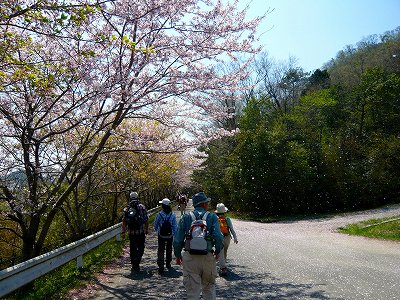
[194,28,400,215]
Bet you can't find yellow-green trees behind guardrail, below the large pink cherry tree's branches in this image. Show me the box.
[57,119,188,244]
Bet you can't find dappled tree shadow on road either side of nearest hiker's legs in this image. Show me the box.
[86,265,339,300]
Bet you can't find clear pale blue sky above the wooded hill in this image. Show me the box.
[244,0,400,71]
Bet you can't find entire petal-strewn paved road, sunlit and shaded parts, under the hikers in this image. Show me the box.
[71,205,400,300]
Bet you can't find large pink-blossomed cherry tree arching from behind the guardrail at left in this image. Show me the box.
[0,0,261,259]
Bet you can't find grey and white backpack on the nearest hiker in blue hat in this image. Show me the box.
[185,211,210,255]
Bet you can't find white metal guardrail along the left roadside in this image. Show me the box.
[0,206,159,297]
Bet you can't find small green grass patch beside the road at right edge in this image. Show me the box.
[339,216,400,241]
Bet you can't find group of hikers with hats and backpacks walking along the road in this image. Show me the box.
[122,192,238,299]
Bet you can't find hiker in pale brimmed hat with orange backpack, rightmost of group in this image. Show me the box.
[215,203,238,276]
